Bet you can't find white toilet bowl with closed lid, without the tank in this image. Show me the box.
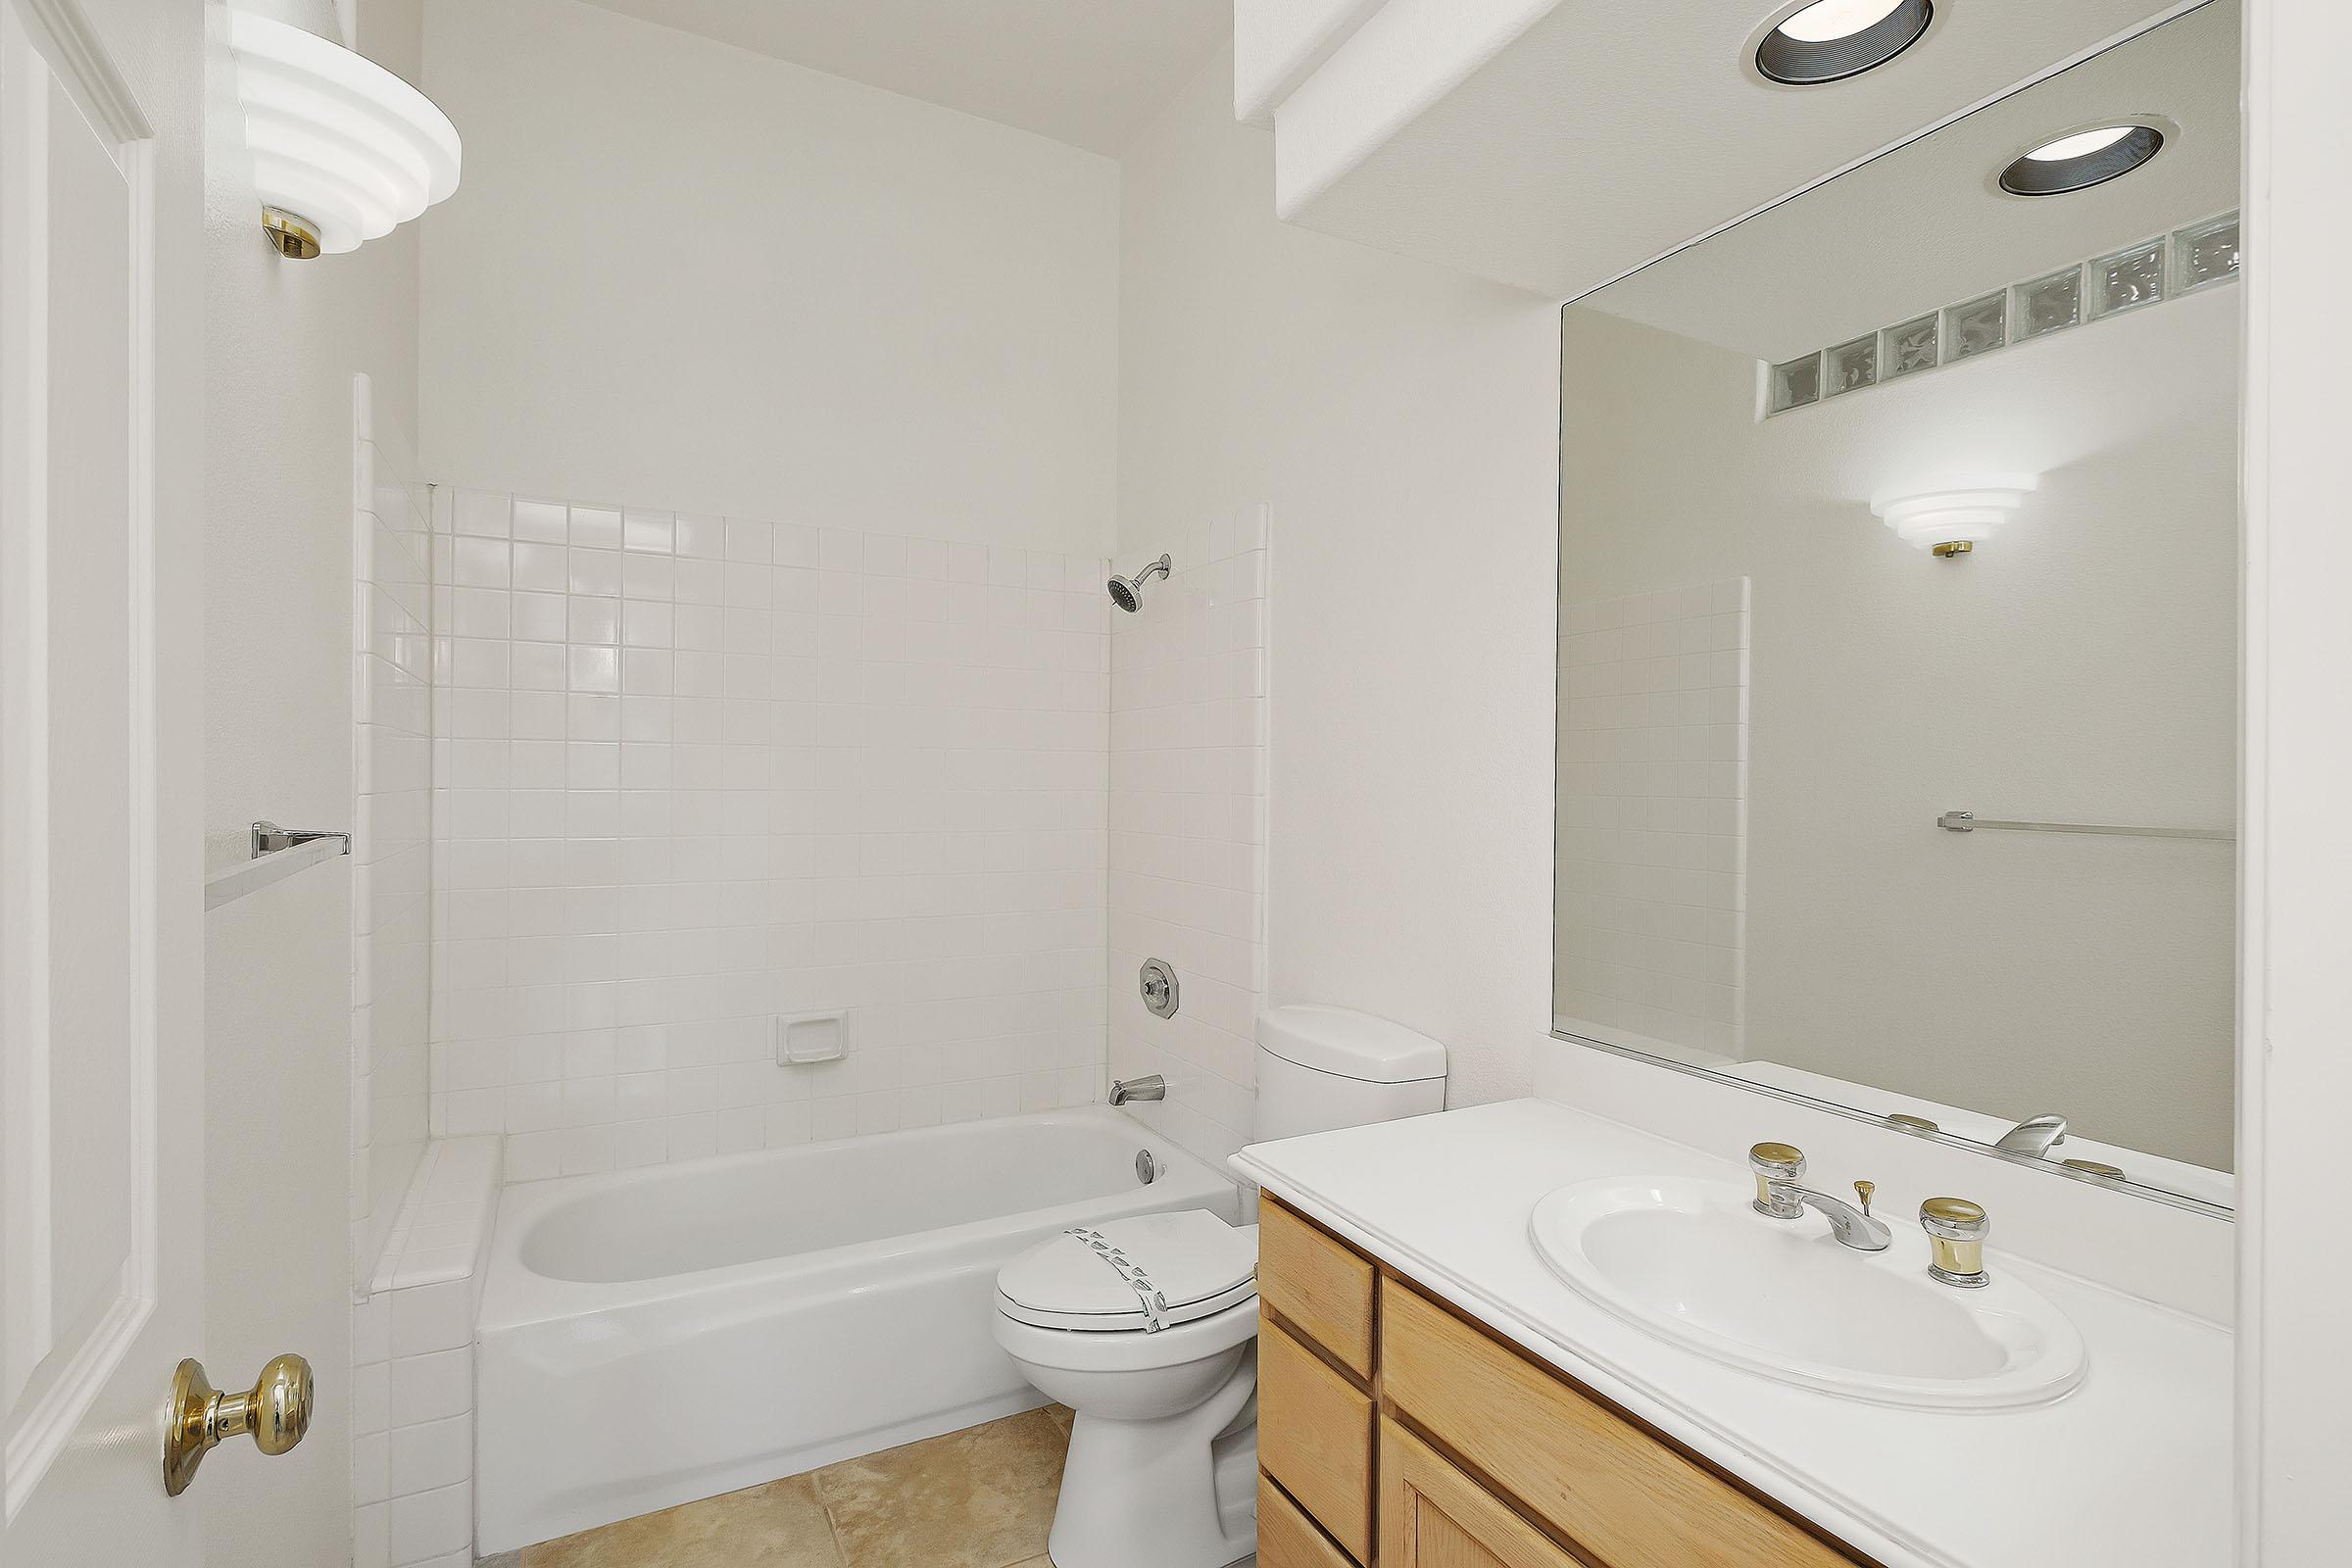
[995,1208,1258,1568]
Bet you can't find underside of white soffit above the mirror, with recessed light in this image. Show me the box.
[1277,0,2211,299]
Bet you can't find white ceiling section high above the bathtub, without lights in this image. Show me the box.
[573,0,1233,158]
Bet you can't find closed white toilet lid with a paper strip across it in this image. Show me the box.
[998,1208,1258,1331]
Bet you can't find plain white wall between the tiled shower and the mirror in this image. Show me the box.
[1119,39,1559,1104]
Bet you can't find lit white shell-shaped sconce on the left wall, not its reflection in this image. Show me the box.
[228,10,459,261]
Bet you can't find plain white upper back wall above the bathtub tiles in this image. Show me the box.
[421,0,1119,555]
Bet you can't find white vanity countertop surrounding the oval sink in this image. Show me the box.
[1233,1101,2232,1568]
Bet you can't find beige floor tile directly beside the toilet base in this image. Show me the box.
[808,1410,1070,1568]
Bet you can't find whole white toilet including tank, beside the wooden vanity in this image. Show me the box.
[995,1004,1446,1568]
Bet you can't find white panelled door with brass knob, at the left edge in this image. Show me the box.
[0,0,204,1568]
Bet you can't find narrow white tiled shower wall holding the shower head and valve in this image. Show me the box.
[1110,508,1268,1168]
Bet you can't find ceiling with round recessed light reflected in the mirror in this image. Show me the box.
[1578,0,2239,362]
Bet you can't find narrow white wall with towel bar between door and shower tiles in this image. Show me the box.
[200,0,421,1563]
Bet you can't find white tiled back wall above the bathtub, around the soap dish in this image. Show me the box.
[433,491,1110,1180]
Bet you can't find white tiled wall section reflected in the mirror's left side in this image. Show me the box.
[1552,578,1747,1060]
